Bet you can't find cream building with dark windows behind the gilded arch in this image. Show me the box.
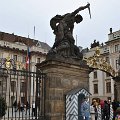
[84,28,120,101]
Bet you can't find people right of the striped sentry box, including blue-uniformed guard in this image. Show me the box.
[81,98,120,120]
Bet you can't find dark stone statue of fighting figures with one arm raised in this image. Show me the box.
[50,3,90,59]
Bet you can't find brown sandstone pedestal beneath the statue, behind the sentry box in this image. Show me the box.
[37,59,89,120]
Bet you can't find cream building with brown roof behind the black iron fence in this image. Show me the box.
[0,32,50,106]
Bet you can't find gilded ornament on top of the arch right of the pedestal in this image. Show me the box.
[84,47,115,77]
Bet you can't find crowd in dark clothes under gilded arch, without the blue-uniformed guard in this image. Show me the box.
[91,100,120,120]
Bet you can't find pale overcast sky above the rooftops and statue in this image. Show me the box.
[0,0,120,48]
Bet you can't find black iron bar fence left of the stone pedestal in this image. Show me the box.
[0,68,45,120]
